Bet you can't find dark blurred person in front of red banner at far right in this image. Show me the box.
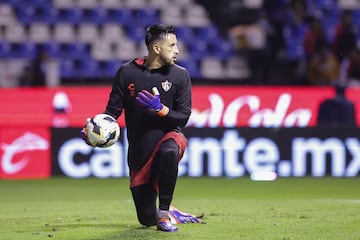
[317,84,356,127]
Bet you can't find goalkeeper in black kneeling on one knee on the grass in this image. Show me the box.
[82,24,199,232]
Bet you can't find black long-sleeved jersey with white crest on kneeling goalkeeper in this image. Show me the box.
[105,58,191,170]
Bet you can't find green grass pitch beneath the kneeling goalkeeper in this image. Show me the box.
[0,178,360,240]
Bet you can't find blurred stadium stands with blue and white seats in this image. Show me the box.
[0,0,360,87]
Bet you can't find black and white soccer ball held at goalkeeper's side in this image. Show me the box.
[85,113,120,148]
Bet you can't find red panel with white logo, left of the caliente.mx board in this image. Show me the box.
[0,129,49,178]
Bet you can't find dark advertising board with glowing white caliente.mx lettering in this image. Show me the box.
[51,128,360,178]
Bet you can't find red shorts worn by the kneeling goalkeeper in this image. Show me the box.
[130,131,187,191]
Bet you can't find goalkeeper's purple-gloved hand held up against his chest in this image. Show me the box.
[136,87,169,116]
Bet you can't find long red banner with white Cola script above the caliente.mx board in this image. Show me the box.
[0,86,360,127]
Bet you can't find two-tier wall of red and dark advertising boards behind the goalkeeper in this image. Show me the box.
[0,86,360,179]
